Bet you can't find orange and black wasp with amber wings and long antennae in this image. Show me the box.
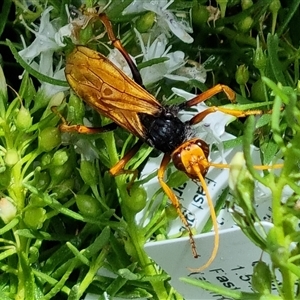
[61,13,272,270]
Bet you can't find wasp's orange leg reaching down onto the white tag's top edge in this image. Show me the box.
[157,153,199,258]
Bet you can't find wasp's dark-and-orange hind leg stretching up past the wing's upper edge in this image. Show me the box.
[99,13,143,86]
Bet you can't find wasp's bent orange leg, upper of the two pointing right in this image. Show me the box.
[181,84,235,108]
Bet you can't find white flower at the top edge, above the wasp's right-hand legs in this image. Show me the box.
[123,0,194,44]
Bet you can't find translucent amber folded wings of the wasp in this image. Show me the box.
[65,46,162,139]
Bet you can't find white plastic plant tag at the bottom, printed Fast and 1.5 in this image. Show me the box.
[145,222,272,300]
